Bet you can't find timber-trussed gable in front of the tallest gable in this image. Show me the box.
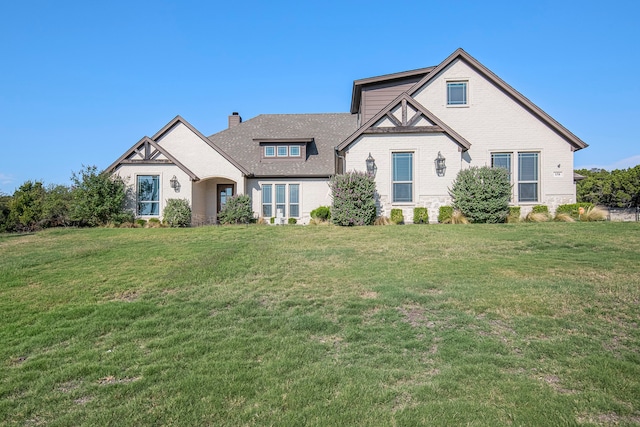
[336,92,471,151]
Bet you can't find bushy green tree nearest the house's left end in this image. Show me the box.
[71,166,133,227]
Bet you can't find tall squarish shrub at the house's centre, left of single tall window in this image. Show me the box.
[329,172,376,226]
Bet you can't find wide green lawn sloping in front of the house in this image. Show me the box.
[0,223,640,426]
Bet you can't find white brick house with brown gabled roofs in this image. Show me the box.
[107,49,587,224]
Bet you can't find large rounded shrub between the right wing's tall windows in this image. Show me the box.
[449,166,511,223]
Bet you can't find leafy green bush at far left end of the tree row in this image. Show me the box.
[7,181,46,231]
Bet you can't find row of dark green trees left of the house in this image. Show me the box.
[0,166,133,232]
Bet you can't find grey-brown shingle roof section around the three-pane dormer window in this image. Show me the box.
[208,113,357,177]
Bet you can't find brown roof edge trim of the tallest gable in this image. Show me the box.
[407,48,588,150]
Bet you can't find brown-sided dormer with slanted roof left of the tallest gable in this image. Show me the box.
[351,67,435,124]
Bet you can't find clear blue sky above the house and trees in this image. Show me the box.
[0,0,640,194]
